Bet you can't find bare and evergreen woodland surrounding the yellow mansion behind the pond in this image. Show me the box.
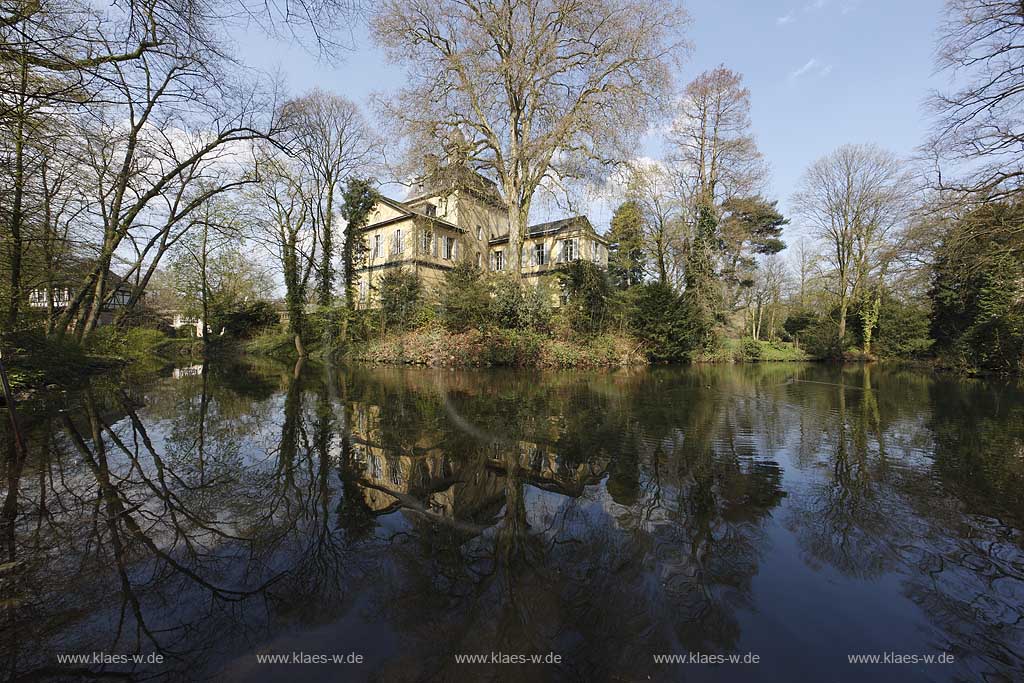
[0,0,1024,373]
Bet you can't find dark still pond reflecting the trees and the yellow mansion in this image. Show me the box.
[0,360,1024,682]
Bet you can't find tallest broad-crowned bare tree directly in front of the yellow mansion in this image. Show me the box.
[373,0,686,276]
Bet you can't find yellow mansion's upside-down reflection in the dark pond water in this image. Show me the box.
[350,403,607,523]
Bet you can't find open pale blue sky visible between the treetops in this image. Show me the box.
[237,0,942,230]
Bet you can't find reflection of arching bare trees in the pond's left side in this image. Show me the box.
[0,360,372,679]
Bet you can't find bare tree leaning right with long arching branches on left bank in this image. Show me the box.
[49,46,273,337]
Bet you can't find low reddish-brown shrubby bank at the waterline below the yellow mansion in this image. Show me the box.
[349,329,647,368]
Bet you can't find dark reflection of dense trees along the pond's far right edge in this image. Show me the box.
[896,380,1024,680]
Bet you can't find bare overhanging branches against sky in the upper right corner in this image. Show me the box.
[926,0,1024,201]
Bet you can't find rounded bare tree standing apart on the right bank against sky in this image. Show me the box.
[793,144,913,342]
